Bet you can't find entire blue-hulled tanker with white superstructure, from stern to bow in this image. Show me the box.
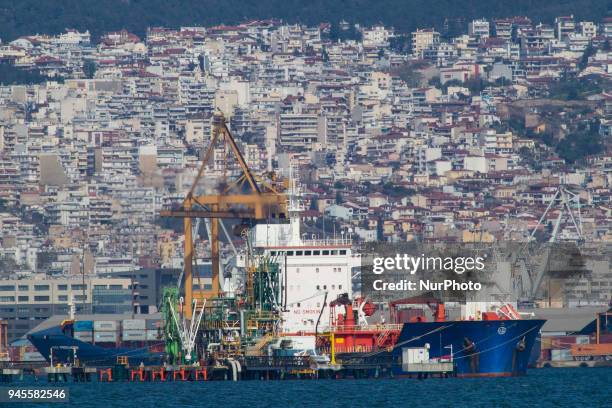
[29,178,544,376]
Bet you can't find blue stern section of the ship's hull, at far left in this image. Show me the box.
[28,327,164,367]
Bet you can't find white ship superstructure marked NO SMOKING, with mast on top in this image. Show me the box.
[251,171,361,333]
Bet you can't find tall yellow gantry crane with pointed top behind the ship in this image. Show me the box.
[160,114,287,316]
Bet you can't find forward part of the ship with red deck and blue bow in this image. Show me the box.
[323,295,545,377]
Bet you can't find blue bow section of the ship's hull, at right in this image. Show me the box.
[393,320,545,377]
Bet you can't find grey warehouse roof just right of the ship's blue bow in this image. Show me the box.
[520,306,609,334]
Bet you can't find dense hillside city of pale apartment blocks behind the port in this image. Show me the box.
[0,16,612,339]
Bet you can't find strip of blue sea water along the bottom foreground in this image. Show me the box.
[2,368,612,408]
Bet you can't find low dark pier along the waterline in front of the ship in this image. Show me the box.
[0,356,454,383]
